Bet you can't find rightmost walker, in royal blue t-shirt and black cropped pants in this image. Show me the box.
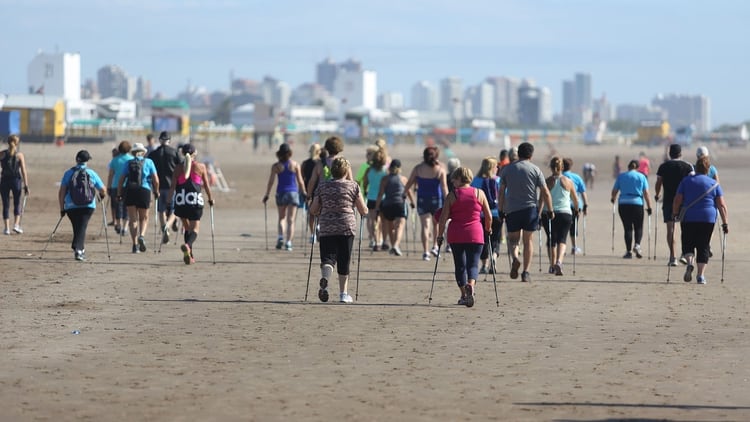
[672,156,729,284]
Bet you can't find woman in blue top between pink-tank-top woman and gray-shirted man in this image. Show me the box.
[472,156,502,274]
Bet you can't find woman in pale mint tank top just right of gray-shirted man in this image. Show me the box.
[539,157,579,275]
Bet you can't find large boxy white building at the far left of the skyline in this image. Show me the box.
[28,51,81,100]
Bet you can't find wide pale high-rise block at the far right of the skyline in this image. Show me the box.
[651,94,711,133]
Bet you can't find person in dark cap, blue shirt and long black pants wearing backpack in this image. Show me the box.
[57,150,107,261]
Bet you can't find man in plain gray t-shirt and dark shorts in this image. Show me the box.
[498,142,554,282]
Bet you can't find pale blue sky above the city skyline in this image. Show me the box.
[0,0,750,126]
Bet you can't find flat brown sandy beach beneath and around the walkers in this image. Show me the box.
[0,140,750,421]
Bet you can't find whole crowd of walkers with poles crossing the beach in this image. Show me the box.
[0,132,729,307]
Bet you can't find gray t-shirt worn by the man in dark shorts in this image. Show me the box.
[500,160,544,214]
